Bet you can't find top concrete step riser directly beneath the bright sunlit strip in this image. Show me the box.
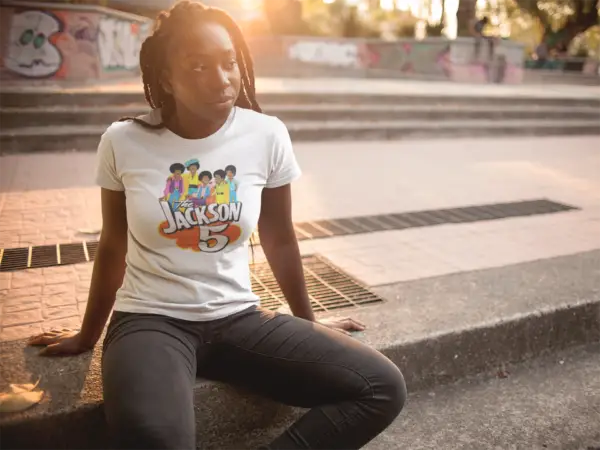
[0,89,600,108]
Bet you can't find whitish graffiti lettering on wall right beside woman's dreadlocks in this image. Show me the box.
[98,17,146,70]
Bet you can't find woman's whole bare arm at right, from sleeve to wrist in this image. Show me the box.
[258,184,315,322]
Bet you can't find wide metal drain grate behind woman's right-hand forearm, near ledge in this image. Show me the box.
[251,255,383,312]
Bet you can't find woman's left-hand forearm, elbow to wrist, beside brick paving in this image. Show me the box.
[81,242,125,345]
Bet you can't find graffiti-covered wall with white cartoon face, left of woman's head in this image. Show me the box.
[0,6,150,81]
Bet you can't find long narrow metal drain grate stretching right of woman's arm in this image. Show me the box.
[294,199,578,240]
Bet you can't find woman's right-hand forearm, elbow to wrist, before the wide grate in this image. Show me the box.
[260,235,315,322]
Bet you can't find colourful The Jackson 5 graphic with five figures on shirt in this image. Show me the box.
[159,158,242,253]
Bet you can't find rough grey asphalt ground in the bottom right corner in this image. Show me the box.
[366,345,600,450]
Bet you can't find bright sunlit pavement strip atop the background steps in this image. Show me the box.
[0,78,600,99]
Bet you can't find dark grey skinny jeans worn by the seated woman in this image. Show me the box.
[102,307,406,450]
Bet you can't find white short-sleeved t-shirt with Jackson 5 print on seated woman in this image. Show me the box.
[97,108,300,321]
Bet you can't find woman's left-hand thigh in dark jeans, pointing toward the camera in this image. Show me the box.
[102,312,196,450]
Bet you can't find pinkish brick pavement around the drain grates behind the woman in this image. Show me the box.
[0,137,600,341]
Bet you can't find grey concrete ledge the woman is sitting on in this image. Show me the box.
[0,251,600,450]
